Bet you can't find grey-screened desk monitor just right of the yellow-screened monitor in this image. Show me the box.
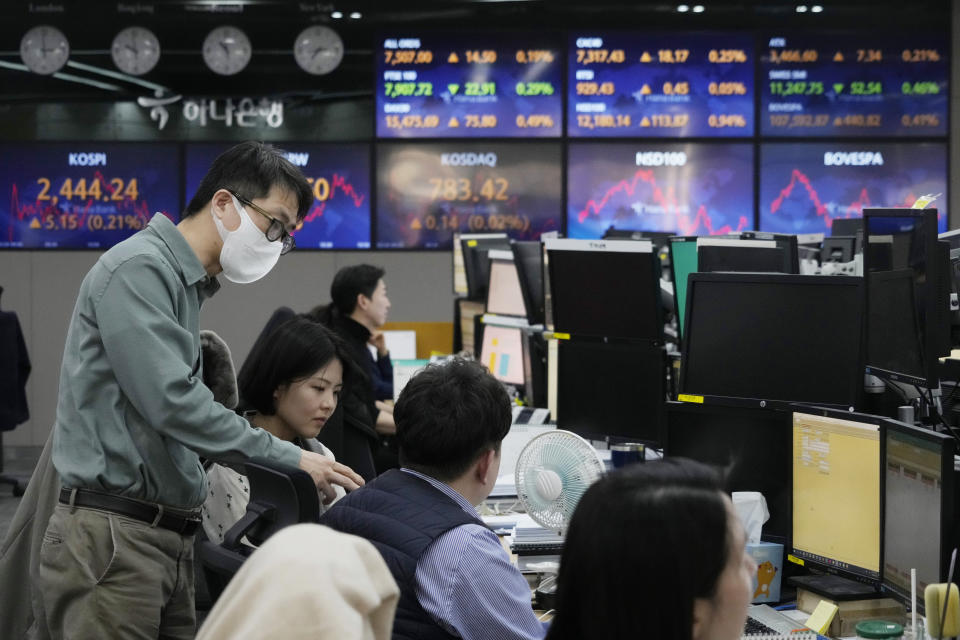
[882,420,957,613]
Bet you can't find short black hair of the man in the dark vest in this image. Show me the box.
[393,358,512,481]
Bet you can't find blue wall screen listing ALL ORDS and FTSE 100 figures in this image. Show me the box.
[376,32,563,138]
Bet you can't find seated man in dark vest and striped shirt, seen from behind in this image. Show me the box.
[320,359,545,640]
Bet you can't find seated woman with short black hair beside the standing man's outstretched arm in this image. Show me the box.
[202,316,350,543]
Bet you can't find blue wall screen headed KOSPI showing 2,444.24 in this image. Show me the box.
[0,142,180,249]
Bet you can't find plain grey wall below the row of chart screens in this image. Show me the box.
[0,251,453,448]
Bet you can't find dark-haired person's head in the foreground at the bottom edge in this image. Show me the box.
[547,458,756,640]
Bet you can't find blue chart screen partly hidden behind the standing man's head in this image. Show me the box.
[187,143,370,250]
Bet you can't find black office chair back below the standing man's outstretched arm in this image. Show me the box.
[197,458,320,606]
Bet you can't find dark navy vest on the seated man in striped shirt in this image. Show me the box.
[320,469,483,640]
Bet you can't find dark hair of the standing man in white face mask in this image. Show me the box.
[183,140,313,222]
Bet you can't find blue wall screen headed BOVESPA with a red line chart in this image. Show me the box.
[760,143,947,234]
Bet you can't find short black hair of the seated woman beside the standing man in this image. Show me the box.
[237,316,352,416]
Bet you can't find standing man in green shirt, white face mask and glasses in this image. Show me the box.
[38,142,363,638]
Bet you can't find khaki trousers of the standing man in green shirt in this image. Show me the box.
[40,504,196,640]
